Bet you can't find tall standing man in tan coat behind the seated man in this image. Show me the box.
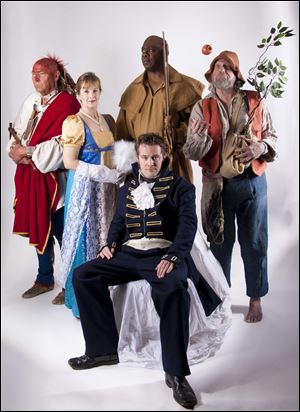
[117,36,204,182]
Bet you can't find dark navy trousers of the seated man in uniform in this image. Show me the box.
[73,246,190,376]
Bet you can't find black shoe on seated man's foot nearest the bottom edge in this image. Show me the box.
[166,373,197,409]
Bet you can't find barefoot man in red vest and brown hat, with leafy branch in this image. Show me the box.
[183,22,293,323]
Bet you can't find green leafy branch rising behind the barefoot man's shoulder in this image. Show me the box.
[246,21,294,128]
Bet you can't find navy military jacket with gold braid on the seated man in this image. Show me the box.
[107,163,197,264]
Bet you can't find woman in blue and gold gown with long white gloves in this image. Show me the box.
[53,72,120,317]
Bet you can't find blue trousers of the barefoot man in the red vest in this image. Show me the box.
[211,171,268,298]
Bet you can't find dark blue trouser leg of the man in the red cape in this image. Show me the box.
[35,207,64,285]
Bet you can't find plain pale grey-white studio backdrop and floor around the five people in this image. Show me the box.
[1,1,299,410]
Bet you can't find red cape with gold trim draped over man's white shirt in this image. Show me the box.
[13,92,80,254]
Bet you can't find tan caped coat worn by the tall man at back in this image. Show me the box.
[116,66,204,182]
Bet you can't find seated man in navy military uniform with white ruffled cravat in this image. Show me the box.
[69,133,221,409]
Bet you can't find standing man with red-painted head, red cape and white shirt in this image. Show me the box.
[9,56,80,303]
